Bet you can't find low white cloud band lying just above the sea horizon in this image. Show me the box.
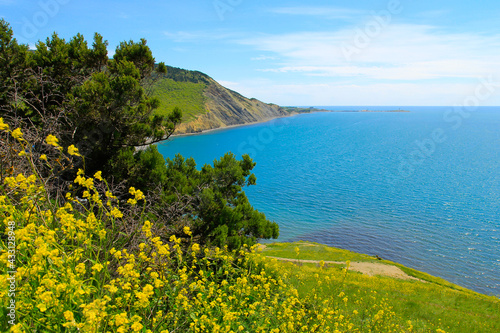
[232,80,500,106]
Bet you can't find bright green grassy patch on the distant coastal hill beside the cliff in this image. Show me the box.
[153,78,207,122]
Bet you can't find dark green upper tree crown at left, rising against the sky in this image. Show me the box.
[0,20,182,175]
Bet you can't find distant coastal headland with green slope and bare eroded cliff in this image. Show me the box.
[150,66,289,134]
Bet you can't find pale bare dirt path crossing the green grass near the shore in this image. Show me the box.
[268,256,422,281]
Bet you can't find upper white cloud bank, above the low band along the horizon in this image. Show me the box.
[240,24,500,81]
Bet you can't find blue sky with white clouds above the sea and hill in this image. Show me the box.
[0,0,500,106]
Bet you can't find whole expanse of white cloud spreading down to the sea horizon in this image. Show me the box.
[161,23,500,106]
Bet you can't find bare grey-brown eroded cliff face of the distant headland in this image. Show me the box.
[175,78,289,134]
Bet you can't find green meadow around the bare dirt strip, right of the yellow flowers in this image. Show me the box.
[262,242,500,332]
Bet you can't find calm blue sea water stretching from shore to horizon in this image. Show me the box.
[159,107,500,295]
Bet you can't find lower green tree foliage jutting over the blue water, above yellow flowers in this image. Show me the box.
[112,146,279,248]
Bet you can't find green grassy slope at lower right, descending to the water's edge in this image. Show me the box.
[263,242,500,332]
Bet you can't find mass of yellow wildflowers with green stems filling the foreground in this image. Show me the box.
[0,126,456,333]
